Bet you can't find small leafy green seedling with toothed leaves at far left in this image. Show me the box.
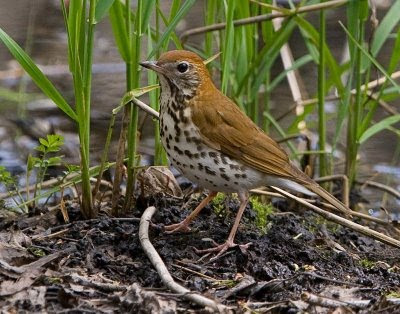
[27,134,64,205]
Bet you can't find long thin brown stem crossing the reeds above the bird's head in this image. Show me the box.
[180,0,349,43]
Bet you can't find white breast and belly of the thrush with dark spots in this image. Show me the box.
[160,78,265,192]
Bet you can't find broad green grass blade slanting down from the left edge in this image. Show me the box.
[0,27,77,121]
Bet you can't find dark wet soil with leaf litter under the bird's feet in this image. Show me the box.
[0,196,400,313]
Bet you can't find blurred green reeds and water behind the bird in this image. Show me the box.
[0,0,400,217]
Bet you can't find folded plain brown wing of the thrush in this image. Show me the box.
[191,89,300,179]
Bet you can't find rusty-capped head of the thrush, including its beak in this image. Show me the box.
[140,50,211,96]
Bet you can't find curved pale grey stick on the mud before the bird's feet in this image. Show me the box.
[139,206,230,313]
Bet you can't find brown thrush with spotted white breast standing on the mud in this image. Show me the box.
[140,50,350,256]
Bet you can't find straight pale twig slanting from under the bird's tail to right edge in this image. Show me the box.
[271,186,400,248]
